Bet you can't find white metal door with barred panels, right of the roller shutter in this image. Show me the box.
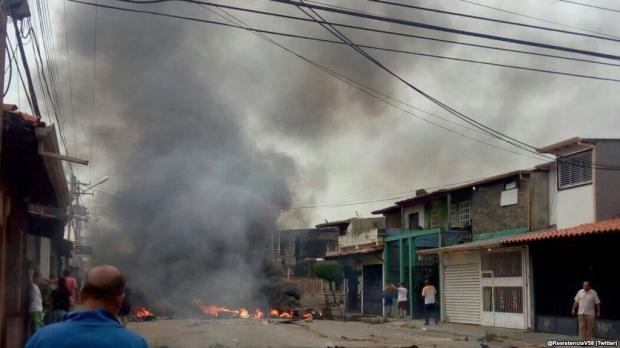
[480,250,527,329]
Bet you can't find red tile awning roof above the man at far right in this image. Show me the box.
[502,218,620,244]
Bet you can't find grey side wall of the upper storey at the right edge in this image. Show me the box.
[593,140,620,220]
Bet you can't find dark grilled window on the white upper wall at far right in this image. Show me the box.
[557,150,592,189]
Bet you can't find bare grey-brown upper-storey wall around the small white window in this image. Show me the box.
[472,176,528,235]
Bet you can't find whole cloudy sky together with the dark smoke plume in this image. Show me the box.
[6,0,620,308]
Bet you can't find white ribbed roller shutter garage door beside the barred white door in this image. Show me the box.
[443,262,480,324]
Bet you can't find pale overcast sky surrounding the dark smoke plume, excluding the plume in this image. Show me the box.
[6,0,620,228]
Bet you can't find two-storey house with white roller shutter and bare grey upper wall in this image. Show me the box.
[376,168,549,329]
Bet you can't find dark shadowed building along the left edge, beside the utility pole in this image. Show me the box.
[0,104,72,348]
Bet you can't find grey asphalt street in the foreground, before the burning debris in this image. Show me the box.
[129,319,544,348]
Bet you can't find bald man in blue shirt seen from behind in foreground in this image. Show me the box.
[26,265,148,348]
